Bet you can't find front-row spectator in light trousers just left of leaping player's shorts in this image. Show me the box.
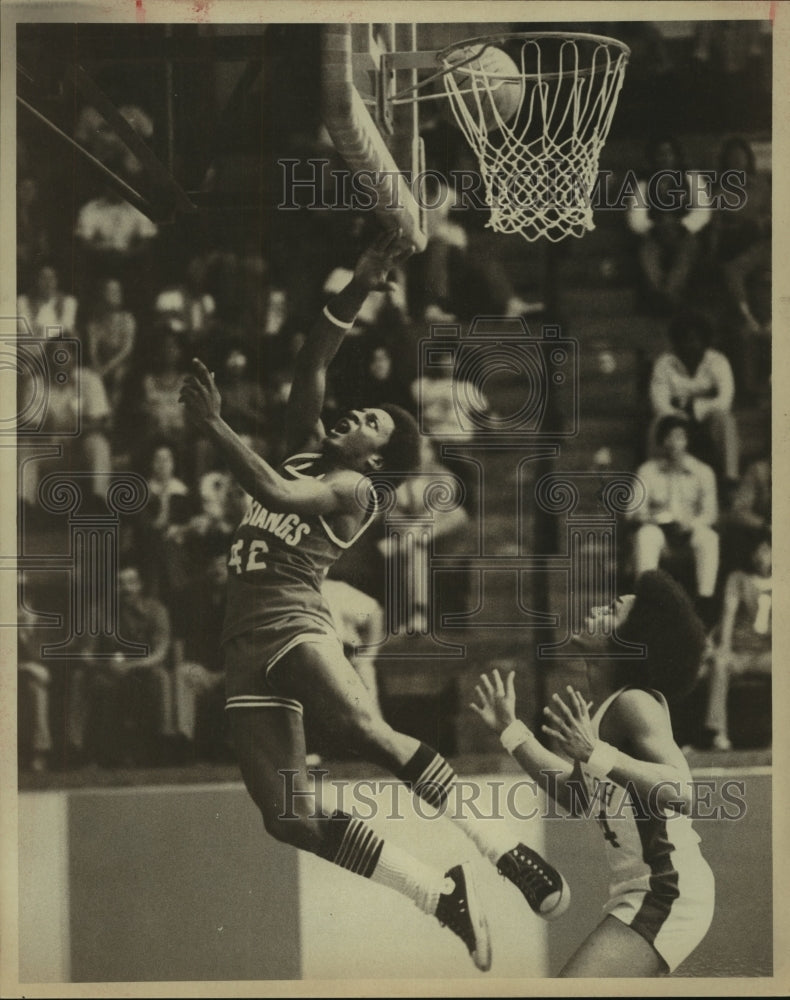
[172,551,228,759]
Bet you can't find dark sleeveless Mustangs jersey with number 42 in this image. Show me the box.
[222,453,376,641]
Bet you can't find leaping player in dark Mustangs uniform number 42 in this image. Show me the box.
[181,231,569,970]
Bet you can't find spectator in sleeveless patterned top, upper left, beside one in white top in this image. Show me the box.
[87,278,137,410]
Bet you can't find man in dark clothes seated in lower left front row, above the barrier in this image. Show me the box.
[92,566,173,766]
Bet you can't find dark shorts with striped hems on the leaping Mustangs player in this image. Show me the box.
[222,612,343,715]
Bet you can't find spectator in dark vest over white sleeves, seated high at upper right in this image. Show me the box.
[626,136,711,311]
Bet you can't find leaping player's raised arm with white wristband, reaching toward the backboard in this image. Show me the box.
[286,229,413,452]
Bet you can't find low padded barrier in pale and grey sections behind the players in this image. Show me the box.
[19,771,772,983]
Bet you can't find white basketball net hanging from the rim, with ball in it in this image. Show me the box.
[439,33,629,242]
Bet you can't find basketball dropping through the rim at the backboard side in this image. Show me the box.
[447,45,524,132]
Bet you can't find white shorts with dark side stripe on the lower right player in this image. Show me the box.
[604,851,715,972]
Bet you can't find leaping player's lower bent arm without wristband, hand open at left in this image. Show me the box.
[180,358,364,516]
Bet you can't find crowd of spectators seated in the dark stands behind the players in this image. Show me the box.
[18,76,771,769]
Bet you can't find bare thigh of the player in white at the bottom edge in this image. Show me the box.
[560,916,669,979]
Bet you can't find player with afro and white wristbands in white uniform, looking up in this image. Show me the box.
[471,570,714,977]
